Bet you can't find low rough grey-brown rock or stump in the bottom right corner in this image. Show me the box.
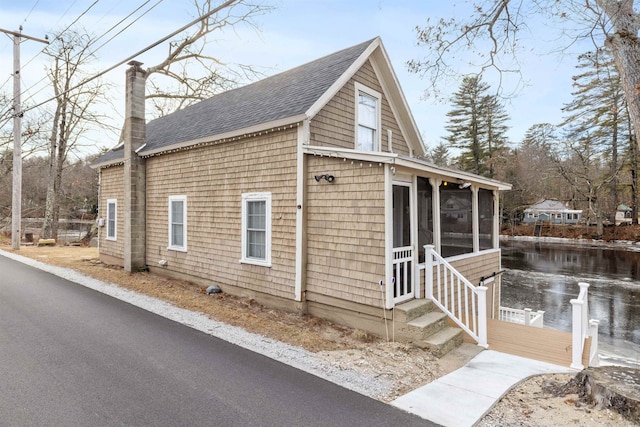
[576,366,640,423]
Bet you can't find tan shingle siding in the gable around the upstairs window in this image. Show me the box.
[310,61,409,155]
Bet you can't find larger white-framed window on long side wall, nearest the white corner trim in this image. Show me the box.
[240,193,271,267]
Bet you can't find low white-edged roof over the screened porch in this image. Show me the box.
[304,145,512,191]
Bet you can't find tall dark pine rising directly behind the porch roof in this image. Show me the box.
[445,76,508,177]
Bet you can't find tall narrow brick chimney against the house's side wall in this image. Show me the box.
[123,61,147,271]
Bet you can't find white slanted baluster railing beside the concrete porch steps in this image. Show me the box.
[424,245,488,348]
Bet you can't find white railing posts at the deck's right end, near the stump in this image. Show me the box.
[571,283,600,369]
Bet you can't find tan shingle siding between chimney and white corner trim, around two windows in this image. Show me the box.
[147,128,297,299]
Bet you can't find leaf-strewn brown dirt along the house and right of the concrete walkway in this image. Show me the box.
[0,238,633,426]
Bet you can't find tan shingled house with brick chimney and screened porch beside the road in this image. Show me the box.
[93,38,510,354]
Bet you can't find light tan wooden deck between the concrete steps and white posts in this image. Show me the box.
[464,319,591,366]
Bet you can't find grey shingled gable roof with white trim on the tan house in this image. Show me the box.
[94,37,422,167]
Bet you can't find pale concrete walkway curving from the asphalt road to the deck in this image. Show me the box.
[391,350,576,427]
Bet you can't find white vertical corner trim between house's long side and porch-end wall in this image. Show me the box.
[294,119,310,301]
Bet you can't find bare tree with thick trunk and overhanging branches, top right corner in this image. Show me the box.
[408,0,640,150]
